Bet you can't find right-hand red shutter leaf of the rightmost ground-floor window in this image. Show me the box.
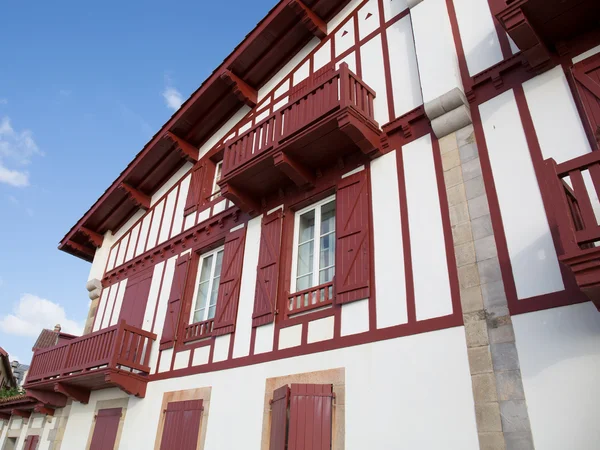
[287,384,333,450]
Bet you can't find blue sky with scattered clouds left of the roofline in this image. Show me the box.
[0,0,276,362]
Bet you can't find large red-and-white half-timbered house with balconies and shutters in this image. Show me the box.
[0,0,600,450]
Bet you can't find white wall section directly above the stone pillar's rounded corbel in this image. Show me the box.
[410,0,463,103]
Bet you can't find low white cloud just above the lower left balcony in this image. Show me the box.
[0,294,83,337]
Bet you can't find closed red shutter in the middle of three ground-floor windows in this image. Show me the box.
[160,400,202,450]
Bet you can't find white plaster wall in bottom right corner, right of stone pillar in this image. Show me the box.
[512,302,600,450]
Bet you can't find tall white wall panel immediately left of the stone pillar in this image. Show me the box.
[402,135,452,320]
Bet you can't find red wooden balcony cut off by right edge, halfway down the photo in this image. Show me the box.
[546,152,600,310]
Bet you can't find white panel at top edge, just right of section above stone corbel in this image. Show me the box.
[454,0,504,75]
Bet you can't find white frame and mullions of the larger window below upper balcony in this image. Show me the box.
[289,193,338,294]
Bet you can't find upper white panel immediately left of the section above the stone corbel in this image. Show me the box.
[387,16,423,117]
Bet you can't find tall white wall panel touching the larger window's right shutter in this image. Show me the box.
[370,150,408,328]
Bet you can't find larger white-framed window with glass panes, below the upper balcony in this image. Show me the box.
[291,197,335,292]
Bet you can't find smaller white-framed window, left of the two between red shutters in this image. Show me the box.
[192,247,224,323]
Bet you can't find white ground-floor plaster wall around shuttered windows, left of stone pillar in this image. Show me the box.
[120,327,479,450]
